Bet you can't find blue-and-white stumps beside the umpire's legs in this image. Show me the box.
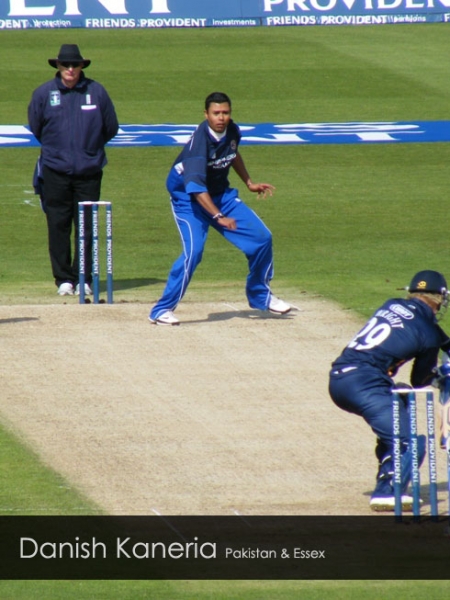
[78,201,113,304]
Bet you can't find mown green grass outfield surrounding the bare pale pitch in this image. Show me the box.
[0,24,450,600]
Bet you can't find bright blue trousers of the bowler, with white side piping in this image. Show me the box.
[150,188,273,319]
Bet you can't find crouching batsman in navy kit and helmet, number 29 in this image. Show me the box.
[329,270,450,511]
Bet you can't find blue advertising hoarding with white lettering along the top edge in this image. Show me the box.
[0,0,450,32]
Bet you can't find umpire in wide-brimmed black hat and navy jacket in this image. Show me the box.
[28,44,119,296]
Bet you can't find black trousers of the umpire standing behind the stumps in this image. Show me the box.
[42,165,103,287]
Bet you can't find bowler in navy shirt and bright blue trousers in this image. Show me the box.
[149,92,291,325]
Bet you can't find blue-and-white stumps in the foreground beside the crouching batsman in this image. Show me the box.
[392,386,450,522]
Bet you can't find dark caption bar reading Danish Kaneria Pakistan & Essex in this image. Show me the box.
[0,516,450,580]
